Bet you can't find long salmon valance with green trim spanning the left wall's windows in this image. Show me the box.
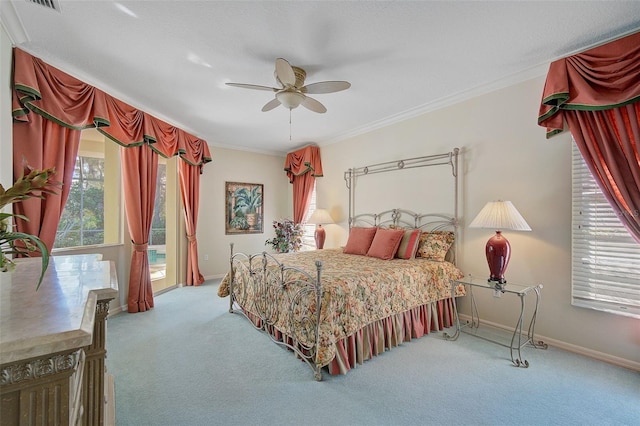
[13,48,211,167]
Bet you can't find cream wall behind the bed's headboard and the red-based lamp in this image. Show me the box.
[317,77,640,368]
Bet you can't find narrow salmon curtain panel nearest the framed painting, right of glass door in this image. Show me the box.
[178,162,204,285]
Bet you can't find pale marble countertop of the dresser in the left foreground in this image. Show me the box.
[0,254,118,364]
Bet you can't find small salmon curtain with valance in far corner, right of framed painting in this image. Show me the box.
[284,145,322,223]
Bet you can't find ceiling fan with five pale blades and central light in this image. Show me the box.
[227,58,351,114]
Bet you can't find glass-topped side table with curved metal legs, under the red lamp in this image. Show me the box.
[444,276,548,368]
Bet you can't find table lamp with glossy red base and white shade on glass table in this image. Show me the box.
[469,200,531,285]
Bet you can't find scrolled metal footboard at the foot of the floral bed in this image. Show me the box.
[229,243,323,381]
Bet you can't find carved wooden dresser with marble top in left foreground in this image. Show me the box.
[0,255,118,426]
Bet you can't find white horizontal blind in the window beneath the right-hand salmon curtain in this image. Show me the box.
[571,143,640,318]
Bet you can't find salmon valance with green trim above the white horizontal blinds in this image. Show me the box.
[538,32,640,138]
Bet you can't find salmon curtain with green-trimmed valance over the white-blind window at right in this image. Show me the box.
[538,33,640,243]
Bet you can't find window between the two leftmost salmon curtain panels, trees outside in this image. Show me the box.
[54,129,122,249]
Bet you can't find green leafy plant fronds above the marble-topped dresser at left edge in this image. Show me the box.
[0,167,60,290]
